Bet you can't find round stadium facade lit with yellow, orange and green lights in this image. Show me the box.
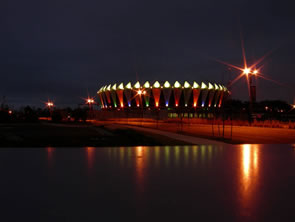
[97,81,229,109]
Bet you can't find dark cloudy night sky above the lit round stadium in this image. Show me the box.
[0,0,295,107]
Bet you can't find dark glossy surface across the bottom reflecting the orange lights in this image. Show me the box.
[0,145,295,222]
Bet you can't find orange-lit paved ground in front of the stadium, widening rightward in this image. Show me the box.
[93,119,295,144]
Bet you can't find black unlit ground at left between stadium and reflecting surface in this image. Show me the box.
[0,122,186,147]
